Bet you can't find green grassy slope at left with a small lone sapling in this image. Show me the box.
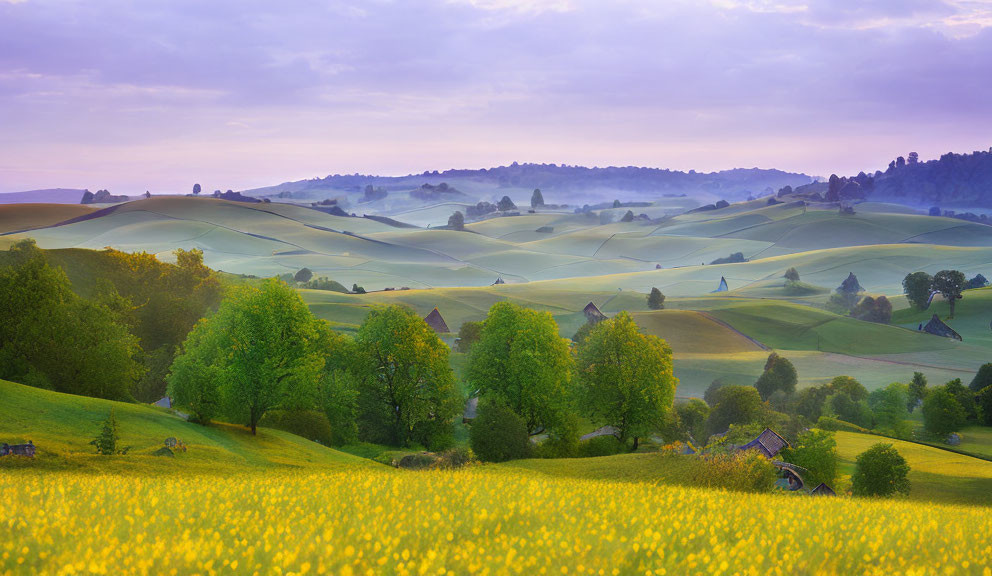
[0,380,370,472]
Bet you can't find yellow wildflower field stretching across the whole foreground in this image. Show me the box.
[0,466,992,576]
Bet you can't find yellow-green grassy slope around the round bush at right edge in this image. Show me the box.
[836,432,992,506]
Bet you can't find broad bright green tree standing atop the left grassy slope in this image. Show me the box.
[170,280,324,434]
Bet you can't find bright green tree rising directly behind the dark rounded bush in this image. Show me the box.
[468,302,573,435]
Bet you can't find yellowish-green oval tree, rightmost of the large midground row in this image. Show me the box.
[578,312,678,450]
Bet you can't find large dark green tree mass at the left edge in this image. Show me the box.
[0,241,144,400]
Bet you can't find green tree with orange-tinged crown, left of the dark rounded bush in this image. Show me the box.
[355,305,461,448]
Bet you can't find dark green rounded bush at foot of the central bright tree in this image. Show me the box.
[469,400,531,462]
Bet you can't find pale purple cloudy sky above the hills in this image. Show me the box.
[0,0,992,194]
